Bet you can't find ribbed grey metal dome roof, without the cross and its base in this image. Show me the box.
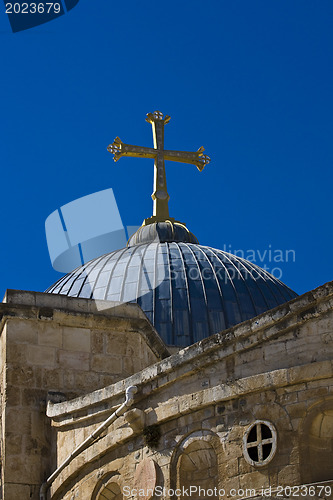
[47,241,297,346]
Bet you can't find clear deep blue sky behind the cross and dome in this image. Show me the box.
[0,0,333,295]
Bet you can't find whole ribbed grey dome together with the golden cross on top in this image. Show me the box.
[47,111,297,347]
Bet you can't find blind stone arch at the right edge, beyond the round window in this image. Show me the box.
[300,398,333,483]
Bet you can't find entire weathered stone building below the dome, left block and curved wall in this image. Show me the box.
[0,283,333,500]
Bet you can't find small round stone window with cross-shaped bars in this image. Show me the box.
[243,420,277,467]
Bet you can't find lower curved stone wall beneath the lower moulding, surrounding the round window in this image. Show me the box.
[52,379,333,500]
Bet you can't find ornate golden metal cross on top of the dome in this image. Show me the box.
[108,111,210,225]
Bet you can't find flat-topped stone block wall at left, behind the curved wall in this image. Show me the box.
[0,292,167,500]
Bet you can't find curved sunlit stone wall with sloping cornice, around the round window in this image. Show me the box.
[48,284,333,500]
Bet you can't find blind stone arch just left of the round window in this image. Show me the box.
[170,430,220,499]
